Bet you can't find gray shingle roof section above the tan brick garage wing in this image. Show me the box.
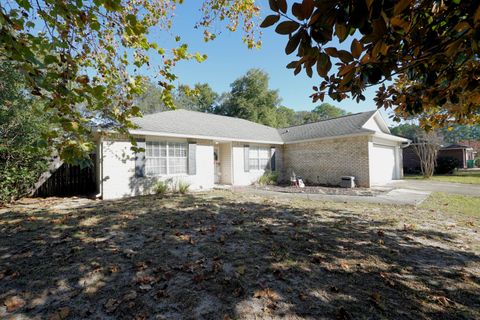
[278,111,376,142]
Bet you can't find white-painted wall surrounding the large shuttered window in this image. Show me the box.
[101,138,214,199]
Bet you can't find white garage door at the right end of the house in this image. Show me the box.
[370,144,396,185]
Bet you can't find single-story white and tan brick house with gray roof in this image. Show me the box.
[96,110,408,199]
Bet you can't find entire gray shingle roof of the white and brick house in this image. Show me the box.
[133,109,376,143]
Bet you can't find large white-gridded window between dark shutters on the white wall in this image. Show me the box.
[145,141,187,176]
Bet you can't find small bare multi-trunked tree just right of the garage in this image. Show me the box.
[412,129,441,178]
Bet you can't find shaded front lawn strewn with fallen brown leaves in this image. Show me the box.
[0,191,480,319]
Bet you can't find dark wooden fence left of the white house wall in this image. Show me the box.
[35,156,96,197]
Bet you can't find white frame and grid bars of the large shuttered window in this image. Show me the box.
[145,140,188,177]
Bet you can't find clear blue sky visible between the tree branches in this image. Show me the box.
[144,0,391,122]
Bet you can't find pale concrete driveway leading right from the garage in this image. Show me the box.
[387,180,480,197]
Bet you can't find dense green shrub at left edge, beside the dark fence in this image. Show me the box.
[0,64,53,203]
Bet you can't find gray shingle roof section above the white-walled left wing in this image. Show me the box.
[132,109,283,143]
